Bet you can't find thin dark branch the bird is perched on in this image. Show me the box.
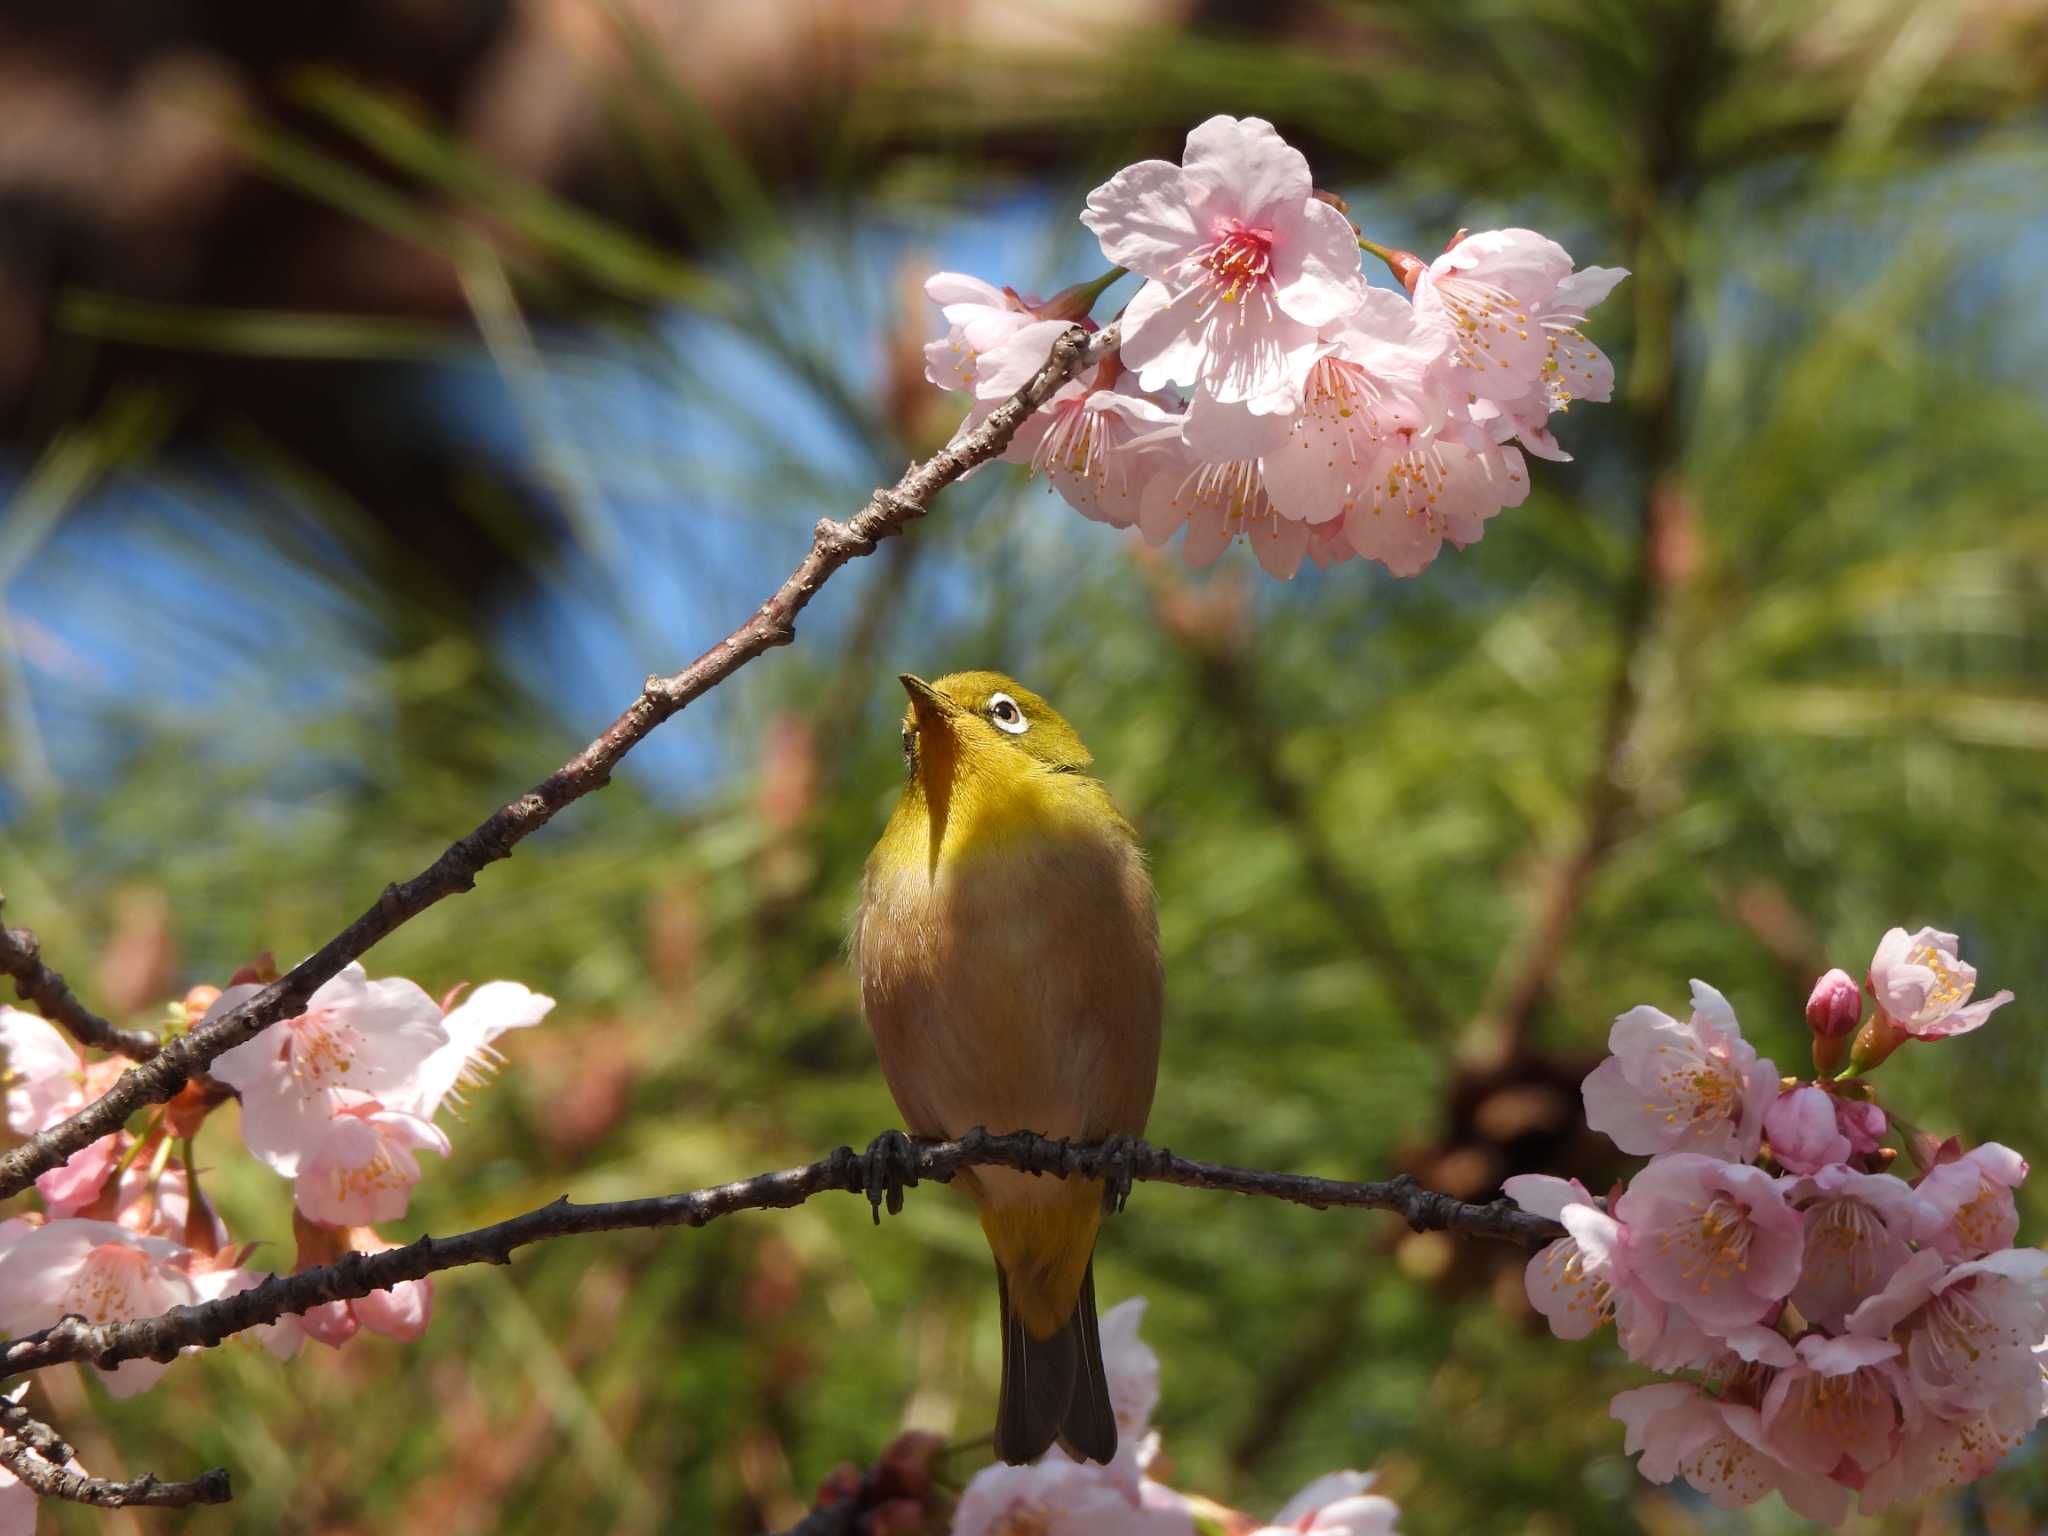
[0,1130,1563,1376]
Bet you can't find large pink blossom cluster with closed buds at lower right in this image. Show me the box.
[1505,928,2048,1524]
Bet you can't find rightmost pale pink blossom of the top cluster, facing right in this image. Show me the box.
[1415,229,1628,459]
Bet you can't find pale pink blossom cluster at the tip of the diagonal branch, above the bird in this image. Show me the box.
[926,117,1626,578]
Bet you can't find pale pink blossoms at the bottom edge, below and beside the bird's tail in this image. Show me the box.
[952,1296,1401,1536]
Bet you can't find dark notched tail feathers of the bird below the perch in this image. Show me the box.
[995,1260,1116,1466]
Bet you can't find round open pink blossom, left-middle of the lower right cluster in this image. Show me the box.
[1614,1153,1804,1333]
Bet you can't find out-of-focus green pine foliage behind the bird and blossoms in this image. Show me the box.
[0,0,2048,1536]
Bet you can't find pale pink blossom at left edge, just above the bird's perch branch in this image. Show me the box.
[0,1221,199,1397]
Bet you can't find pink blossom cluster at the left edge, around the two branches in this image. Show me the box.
[0,965,555,1417]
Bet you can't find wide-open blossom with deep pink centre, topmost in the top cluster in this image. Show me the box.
[1081,117,1366,412]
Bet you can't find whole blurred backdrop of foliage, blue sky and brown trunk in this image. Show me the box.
[0,0,2048,1536]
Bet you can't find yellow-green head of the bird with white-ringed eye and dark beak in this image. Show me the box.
[899,672,1094,791]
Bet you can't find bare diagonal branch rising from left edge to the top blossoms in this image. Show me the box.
[0,324,1118,1200]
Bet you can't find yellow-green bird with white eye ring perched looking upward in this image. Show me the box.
[854,672,1163,1462]
